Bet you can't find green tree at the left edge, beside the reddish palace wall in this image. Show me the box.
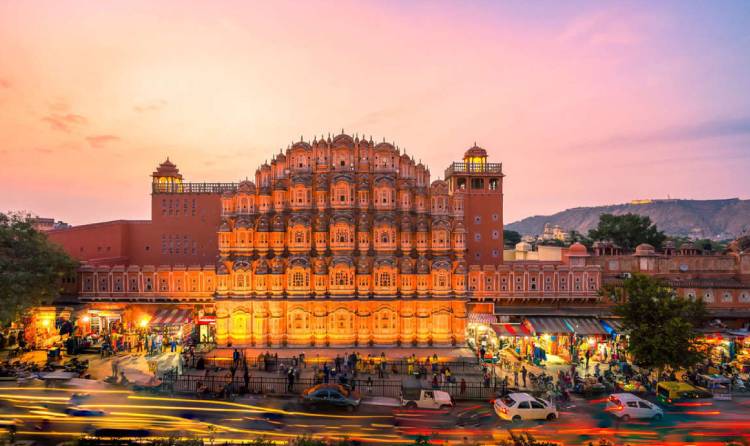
[0,213,77,325]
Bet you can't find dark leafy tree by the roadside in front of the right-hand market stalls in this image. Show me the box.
[603,274,708,370]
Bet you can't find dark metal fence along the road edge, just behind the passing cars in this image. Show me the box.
[161,371,498,400]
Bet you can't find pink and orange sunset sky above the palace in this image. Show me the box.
[0,0,750,224]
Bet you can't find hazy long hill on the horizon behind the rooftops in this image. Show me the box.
[505,198,750,239]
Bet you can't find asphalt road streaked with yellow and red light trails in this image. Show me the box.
[0,383,750,445]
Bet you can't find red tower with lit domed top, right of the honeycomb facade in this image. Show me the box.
[445,144,505,265]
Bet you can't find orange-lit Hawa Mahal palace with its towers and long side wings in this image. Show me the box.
[47,132,750,347]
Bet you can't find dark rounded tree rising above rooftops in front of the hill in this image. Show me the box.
[589,214,666,251]
